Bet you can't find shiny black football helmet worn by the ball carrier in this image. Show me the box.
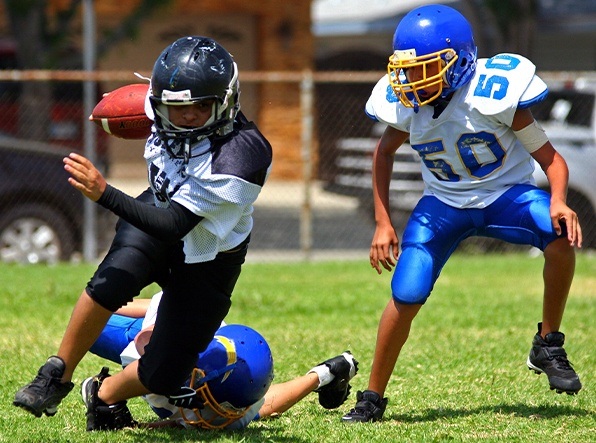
[149,36,240,143]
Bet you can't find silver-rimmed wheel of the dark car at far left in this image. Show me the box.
[0,204,75,264]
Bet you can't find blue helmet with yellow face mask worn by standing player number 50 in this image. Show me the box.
[387,5,478,110]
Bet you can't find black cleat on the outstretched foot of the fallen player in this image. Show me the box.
[315,351,358,409]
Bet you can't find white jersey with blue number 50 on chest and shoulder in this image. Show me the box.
[366,54,548,208]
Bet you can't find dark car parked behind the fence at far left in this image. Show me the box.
[0,135,113,263]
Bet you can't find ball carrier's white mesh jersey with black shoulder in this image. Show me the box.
[145,119,271,263]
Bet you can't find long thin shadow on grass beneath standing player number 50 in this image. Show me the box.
[385,403,594,423]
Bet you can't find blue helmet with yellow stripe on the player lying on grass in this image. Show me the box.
[180,325,273,429]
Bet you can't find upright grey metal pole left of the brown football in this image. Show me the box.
[83,0,97,261]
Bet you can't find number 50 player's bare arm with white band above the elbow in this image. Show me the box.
[511,109,582,248]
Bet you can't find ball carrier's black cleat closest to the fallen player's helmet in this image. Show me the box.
[81,367,138,431]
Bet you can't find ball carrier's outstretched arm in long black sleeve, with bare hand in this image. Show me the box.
[63,153,203,242]
